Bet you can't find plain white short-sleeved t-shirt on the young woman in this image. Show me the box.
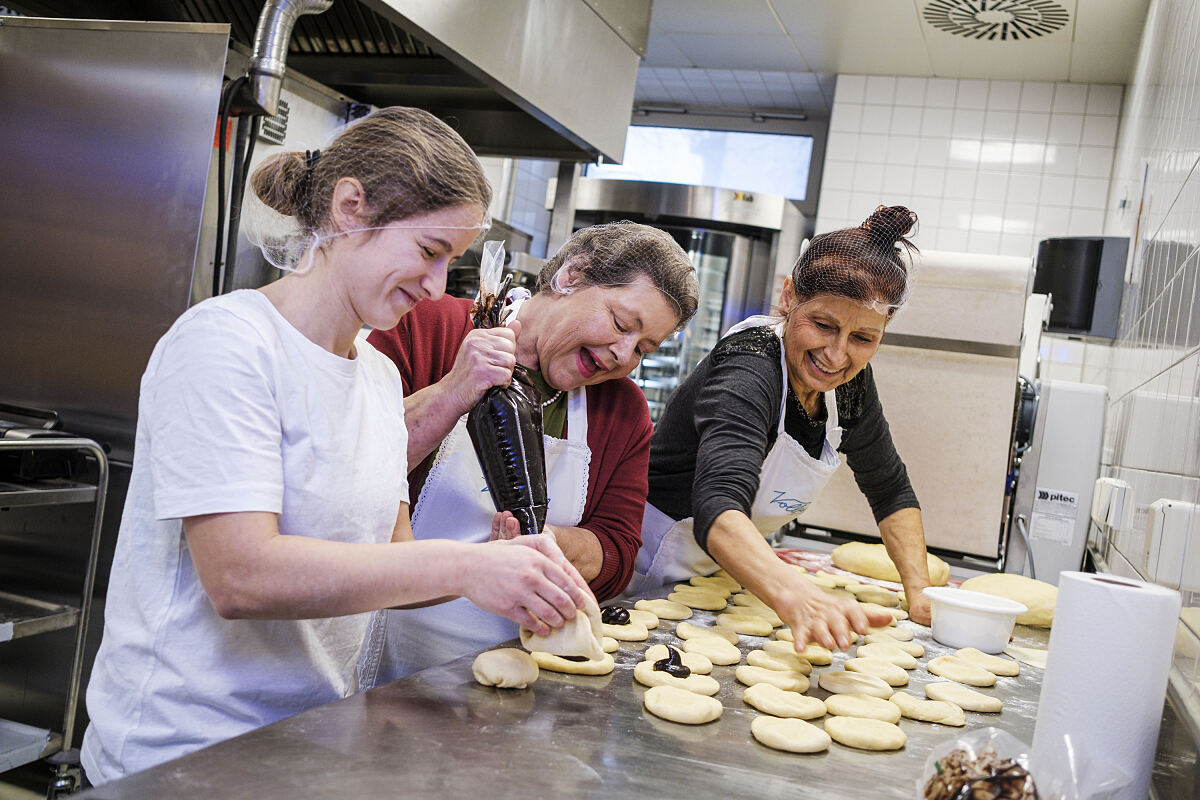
[82,290,408,784]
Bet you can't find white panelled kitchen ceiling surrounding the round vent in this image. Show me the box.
[636,0,1150,119]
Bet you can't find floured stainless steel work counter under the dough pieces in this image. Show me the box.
[80,604,1048,800]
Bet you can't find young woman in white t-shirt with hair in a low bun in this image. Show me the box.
[82,108,588,784]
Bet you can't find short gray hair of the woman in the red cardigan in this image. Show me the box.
[534,219,700,330]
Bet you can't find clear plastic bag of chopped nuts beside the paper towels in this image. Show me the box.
[917,728,1039,800]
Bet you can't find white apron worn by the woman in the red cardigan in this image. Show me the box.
[359,386,592,688]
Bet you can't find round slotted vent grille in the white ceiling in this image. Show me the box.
[924,0,1069,42]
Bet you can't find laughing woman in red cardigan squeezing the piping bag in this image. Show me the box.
[360,222,698,687]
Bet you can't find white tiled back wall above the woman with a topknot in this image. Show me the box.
[816,74,1123,255]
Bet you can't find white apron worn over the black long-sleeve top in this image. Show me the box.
[625,317,841,596]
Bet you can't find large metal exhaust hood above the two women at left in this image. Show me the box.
[6,0,650,161]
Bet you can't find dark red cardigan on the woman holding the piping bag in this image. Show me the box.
[367,296,653,601]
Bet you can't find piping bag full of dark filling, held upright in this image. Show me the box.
[467,241,547,534]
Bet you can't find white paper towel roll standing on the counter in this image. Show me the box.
[1031,572,1180,800]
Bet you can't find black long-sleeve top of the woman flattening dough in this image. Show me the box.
[648,327,919,552]
